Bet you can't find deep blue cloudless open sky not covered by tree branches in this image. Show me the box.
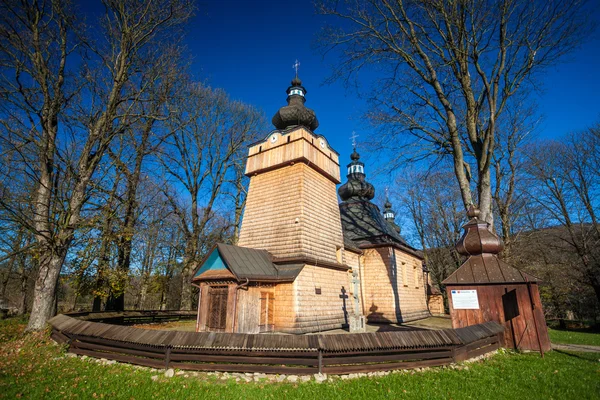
[187,0,600,165]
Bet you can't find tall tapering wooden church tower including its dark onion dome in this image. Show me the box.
[238,76,344,264]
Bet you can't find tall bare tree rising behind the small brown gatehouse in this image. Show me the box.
[317,0,588,223]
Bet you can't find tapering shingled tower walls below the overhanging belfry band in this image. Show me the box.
[238,163,343,262]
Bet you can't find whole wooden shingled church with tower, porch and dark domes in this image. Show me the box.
[192,77,429,333]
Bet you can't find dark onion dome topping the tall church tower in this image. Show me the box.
[271,76,319,131]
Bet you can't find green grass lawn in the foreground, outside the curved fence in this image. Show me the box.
[0,319,600,400]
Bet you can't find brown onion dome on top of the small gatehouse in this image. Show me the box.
[456,206,504,256]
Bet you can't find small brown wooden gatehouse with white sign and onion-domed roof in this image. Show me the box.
[442,208,551,352]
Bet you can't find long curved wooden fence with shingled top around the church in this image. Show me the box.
[50,311,504,374]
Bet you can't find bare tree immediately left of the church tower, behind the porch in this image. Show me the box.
[161,84,262,310]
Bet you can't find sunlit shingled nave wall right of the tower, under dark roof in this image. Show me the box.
[361,247,429,323]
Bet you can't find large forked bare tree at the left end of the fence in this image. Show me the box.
[1,0,193,330]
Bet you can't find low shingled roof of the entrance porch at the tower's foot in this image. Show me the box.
[193,243,304,281]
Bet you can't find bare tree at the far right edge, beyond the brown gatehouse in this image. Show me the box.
[527,128,600,303]
